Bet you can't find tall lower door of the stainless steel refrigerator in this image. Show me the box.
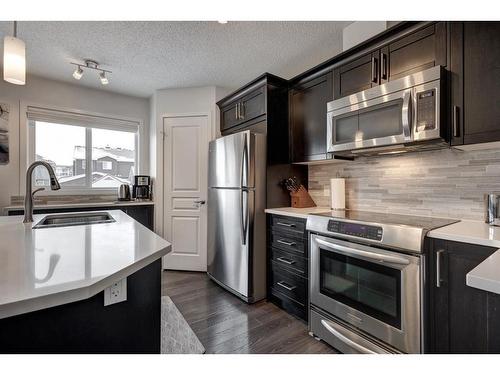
[208,188,255,299]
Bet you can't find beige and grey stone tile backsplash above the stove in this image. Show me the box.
[309,149,500,220]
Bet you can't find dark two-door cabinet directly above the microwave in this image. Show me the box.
[334,22,447,99]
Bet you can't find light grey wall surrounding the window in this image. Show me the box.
[0,76,150,215]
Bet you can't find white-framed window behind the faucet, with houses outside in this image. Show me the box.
[28,110,138,190]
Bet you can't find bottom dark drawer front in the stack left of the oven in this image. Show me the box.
[271,261,307,306]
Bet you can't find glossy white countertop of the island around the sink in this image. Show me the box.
[0,210,171,319]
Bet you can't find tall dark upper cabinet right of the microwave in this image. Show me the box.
[450,22,500,145]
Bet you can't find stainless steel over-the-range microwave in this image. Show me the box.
[327,66,449,156]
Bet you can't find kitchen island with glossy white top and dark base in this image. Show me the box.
[0,210,170,353]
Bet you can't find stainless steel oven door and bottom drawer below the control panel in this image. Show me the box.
[310,234,422,353]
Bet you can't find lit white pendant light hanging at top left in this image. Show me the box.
[3,21,26,85]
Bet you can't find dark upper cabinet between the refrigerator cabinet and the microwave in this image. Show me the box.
[289,71,333,163]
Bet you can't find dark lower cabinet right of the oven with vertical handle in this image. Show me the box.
[426,240,500,353]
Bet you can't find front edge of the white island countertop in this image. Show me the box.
[0,243,172,319]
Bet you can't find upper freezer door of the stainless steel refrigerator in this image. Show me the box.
[208,131,255,188]
